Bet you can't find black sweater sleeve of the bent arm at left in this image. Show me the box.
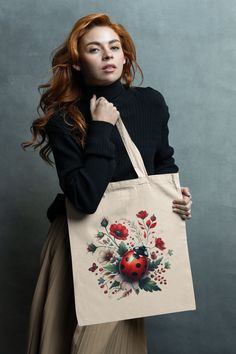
[46,115,115,214]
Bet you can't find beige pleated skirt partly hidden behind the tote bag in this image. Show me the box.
[27,215,147,354]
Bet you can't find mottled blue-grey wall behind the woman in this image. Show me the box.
[0,0,236,354]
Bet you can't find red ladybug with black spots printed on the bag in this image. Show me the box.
[120,246,148,281]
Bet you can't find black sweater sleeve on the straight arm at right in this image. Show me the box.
[149,87,179,174]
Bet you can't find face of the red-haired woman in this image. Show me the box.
[73,26,126,86]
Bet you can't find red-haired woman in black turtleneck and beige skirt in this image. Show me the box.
[23,13,192,354]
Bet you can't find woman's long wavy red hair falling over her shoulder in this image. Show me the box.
[21,13,143,165]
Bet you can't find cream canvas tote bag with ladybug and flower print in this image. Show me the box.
[66,117,196,326]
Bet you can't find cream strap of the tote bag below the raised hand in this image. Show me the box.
[116,117,148,177]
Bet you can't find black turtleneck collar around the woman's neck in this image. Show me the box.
[79,79,124,101]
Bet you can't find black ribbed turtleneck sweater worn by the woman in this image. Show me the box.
[46,79,179,222]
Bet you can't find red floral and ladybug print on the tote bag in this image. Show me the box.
[87,210,173,299]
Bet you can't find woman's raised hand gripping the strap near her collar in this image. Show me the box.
[90,94,120,125]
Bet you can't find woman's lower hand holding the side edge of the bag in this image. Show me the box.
[172,187,192,220]
